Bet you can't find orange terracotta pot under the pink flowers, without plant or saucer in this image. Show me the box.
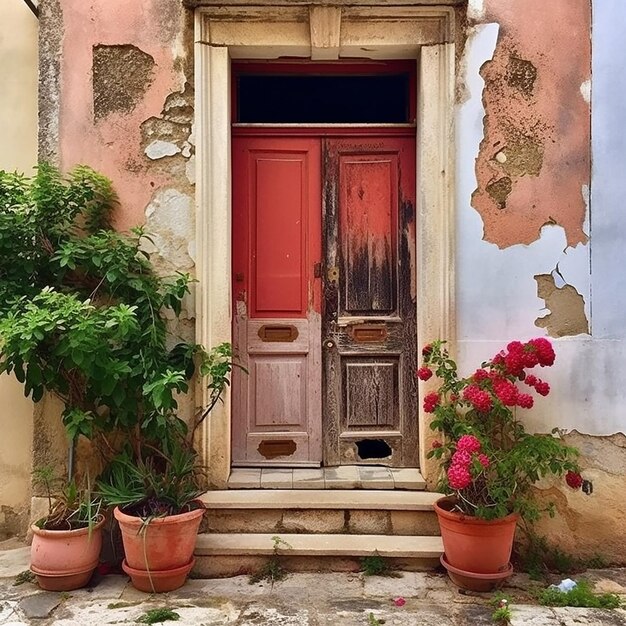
[435,498,519,574]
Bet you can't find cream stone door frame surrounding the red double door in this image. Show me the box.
[193,0,459,488]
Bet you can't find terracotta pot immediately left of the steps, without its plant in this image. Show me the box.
[113,507,204,591]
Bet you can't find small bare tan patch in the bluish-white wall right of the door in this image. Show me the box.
[535,270,589,337]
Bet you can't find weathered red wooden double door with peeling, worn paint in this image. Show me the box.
[232,133,418,467]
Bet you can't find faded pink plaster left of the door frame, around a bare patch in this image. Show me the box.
[59,0,185,230]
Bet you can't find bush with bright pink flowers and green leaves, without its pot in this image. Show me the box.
[416,338,582,521]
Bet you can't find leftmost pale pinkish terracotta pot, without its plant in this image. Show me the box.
[30,517,104,591]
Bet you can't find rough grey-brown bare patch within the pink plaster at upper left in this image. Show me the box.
[92,45,154,121]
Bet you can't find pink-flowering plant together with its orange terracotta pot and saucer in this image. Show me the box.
[417,338,582,590]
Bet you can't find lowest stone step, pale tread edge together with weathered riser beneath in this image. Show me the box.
[194,533,443,576]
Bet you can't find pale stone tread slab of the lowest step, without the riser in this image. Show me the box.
[195,533,443,559]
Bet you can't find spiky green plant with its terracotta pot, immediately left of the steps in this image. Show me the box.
[98,344,233,593]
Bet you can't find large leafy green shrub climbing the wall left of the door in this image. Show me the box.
[0,164,232,588]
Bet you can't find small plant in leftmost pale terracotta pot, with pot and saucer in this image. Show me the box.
[30,467,104,591]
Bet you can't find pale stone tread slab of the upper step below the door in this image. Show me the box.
[200,489,441,511]
